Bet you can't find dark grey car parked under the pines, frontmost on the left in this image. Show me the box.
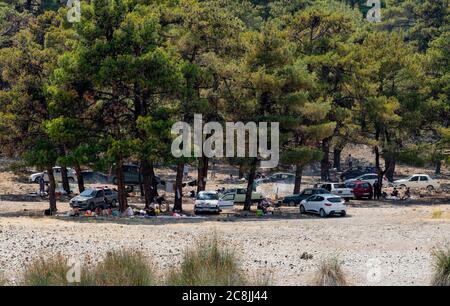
[70,188,119,210]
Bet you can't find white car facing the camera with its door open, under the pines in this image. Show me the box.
[194,191,234,213]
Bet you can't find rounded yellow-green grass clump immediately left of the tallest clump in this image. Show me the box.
[87,250,156,286]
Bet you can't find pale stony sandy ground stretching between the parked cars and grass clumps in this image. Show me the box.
[0,201,450,285]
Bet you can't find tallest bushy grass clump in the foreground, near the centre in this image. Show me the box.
[167,238,248,286]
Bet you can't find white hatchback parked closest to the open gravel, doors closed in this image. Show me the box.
[300,194,347,218]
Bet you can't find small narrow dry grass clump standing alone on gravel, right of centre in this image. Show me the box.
[313,257,347,286]
